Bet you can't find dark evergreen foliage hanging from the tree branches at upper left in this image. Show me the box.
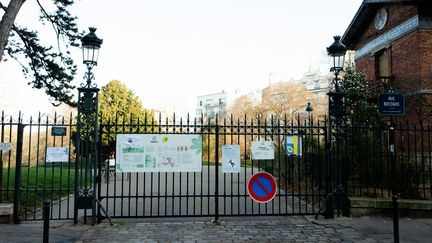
[2,0,82,106]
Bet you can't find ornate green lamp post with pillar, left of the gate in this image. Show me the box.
[74,28,102,224]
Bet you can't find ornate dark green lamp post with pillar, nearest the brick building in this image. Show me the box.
[326,36,349,218]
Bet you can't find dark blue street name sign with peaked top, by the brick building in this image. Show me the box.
[378,87,405,116]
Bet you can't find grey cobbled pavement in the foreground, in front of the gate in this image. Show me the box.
[0,216,432,242]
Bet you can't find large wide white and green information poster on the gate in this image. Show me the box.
[116,134,202,172]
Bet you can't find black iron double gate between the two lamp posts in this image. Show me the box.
[97,116,327,220]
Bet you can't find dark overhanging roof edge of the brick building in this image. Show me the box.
[341,0,428,50]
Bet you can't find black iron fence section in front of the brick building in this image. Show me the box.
[347,121,432,199]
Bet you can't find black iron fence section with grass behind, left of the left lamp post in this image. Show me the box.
[0,112,75,222]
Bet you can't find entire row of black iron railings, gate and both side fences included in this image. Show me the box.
[0,113,432,221]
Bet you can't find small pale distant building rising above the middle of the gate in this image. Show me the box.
[196,91,227,119]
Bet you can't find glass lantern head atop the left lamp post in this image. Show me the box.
[81,27,103,88]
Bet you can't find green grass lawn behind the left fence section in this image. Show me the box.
[3,163,88,212]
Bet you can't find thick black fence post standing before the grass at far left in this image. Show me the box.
[13,122,24,224]
